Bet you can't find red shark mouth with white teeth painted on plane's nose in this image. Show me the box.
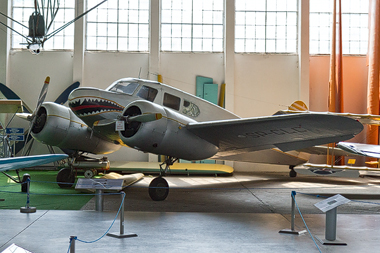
[69,97,124,116]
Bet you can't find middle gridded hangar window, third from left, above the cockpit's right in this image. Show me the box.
[161,0,224,52]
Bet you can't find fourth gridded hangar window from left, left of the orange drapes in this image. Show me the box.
[235,0,298,53]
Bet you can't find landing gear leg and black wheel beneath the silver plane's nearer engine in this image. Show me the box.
[149,156,178,201]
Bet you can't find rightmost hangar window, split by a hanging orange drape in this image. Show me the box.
[310,0,369,54]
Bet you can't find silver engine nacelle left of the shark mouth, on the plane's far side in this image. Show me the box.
[31,102,121,154]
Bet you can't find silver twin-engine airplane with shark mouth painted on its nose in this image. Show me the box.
[20,78,363,201]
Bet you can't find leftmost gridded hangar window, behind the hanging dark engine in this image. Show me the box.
[10,0,75,50]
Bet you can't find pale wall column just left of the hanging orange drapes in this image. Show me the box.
[298,0,310,106]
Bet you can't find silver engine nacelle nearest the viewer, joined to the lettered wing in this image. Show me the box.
[119,100,218,160]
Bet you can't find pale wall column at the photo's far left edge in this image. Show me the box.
[0,0,11,86]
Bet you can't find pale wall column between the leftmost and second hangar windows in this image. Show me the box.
[73,0,86,85]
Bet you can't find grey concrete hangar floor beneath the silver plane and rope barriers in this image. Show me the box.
[0,172,380,253]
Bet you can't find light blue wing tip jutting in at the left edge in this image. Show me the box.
[0,154,67,172]
